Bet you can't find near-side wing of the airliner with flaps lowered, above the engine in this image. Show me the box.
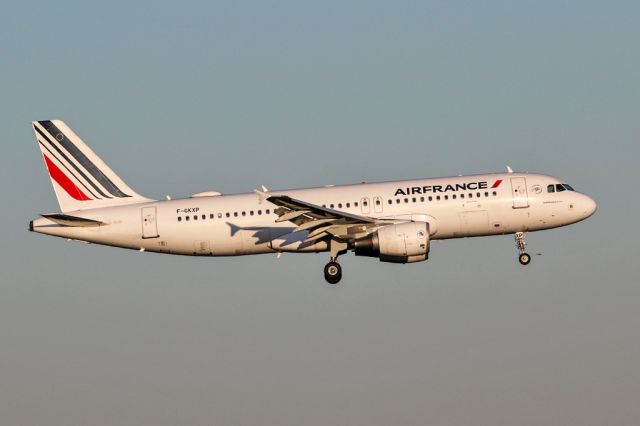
[265,195,397,242]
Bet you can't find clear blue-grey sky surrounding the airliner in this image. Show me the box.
[0,0,640,426]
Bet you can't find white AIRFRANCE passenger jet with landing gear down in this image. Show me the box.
[29,120,597,284]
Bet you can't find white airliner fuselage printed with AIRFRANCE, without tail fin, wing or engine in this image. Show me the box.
[31,173,596,256]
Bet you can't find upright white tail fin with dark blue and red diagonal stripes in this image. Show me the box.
[32,120,150,212]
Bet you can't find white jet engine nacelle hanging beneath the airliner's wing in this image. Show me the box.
[354,222,430,263]
